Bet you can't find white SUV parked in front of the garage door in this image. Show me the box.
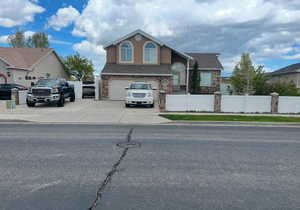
[125,82,155,107]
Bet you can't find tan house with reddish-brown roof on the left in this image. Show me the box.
[0,47,68,87]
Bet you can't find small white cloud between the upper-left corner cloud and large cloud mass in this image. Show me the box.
[47,6,80,31]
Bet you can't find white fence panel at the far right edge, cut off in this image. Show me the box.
[278,96,300,113]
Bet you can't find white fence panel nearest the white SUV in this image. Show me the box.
[166,95,214,112]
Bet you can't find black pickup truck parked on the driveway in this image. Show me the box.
[27,79,75,107]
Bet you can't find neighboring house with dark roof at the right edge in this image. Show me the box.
[267,63,300,88]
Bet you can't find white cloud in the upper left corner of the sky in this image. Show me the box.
[0,0,45,27]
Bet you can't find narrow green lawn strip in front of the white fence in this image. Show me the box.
[160,114,300,123]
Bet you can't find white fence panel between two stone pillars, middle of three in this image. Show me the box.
[221,95,272,113]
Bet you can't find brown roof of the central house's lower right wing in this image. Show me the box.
[187,53,223,70]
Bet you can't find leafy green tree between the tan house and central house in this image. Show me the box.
[64,53,95,81]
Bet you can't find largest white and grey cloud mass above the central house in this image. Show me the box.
[65,0,300,72]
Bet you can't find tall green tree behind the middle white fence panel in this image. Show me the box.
[231,53,262,95]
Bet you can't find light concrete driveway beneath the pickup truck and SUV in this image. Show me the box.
[0,99,169,124]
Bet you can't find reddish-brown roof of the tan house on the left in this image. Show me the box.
[0,47,54,70]
